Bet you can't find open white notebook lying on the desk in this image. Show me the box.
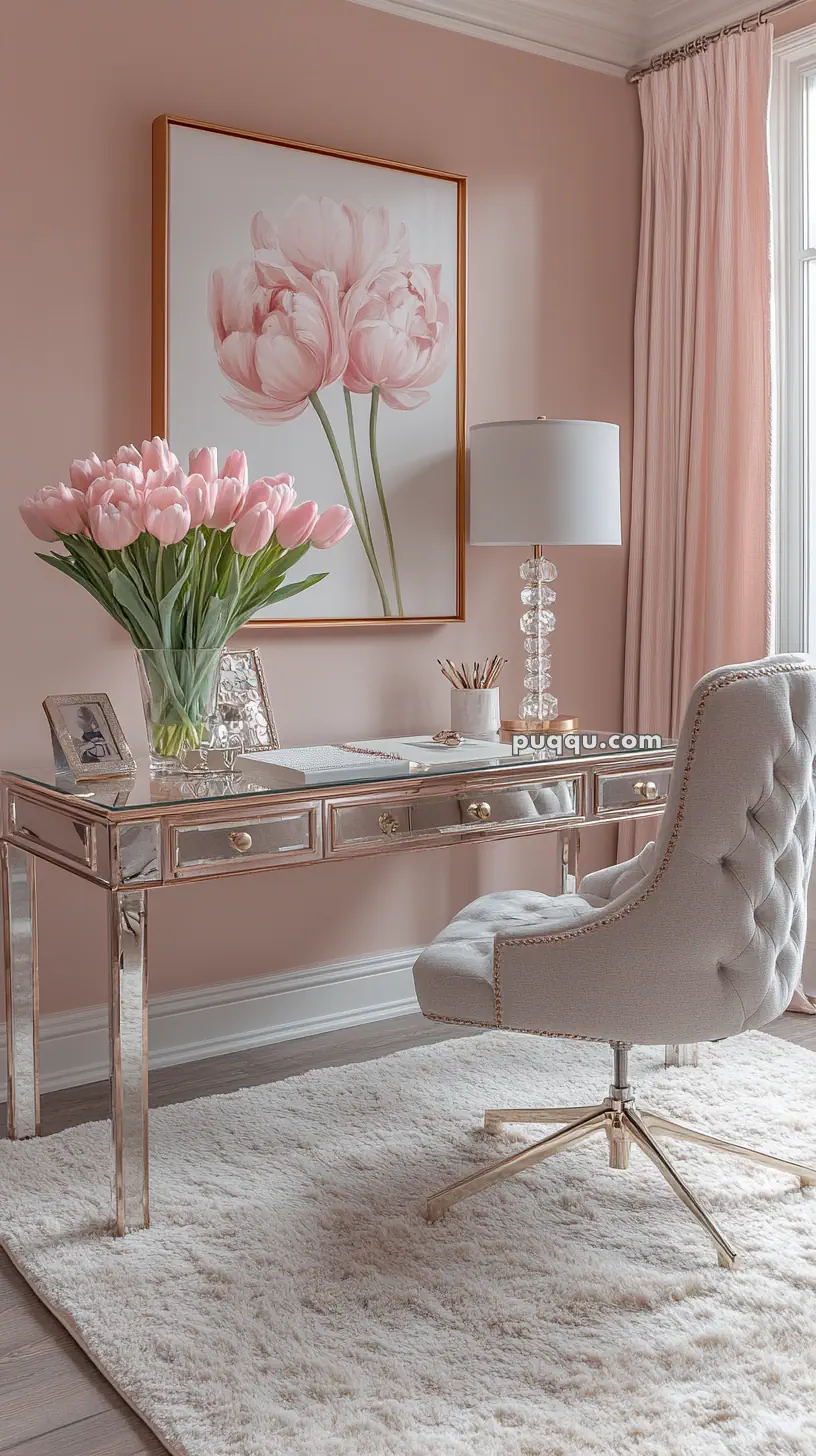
[238,734,513,788]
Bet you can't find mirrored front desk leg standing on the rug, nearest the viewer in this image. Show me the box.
[109,890,150,1235]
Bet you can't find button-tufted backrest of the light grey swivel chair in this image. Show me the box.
[648,655,816,1026]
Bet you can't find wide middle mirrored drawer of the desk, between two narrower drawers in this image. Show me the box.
[328,778,581,855]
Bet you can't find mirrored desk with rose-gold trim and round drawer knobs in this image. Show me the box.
[0,745,683,1235]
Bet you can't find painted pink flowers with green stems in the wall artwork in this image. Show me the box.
[210,197,453,616]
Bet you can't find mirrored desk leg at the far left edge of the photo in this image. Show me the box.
[1,844,39,1137]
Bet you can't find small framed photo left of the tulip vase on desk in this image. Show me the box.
[42,693,136,783]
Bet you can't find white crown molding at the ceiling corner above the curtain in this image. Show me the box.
[342,0,786,76]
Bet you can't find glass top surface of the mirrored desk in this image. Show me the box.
[3,734,675,811]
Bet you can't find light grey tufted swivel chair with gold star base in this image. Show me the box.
[414,655,816,1267]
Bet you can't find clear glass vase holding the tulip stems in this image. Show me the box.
[136,648,221,773]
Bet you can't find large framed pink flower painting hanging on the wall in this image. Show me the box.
[153,116,466,626]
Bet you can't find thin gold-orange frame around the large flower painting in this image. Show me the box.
[152,115,466,629]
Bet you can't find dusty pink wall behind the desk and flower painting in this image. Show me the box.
[0,0,640,1010]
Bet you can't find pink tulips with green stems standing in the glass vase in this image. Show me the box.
[20,437,353,760]
